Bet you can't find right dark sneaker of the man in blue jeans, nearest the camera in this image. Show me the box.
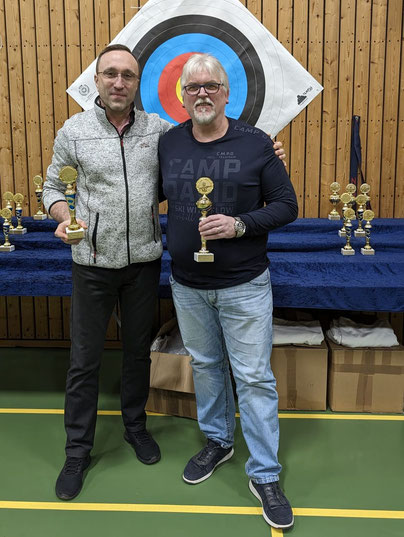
[248,480,294,528]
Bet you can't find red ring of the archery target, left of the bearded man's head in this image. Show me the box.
[158,52,194,123]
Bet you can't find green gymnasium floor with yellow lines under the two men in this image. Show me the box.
[0,348,404,537]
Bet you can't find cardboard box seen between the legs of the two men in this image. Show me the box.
[146,319,197,419]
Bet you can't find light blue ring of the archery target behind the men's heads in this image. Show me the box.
[140,33,248,124]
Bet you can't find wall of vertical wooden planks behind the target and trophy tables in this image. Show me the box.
[0,0,404,345]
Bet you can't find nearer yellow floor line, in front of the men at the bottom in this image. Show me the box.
[0,501,404,516]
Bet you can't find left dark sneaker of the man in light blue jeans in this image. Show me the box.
[182,439,234,485]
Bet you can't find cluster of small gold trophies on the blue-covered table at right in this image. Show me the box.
[328,182,375,255]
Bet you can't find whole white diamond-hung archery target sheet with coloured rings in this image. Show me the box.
[67,0,322,136]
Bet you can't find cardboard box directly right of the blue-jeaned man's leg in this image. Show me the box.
[271,342,328,410]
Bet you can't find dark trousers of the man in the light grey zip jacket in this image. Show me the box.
[65,259,161,457]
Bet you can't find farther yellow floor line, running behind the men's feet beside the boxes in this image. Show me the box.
[0,408,404,421]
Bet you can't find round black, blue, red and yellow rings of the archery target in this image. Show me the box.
[133,15,265,124]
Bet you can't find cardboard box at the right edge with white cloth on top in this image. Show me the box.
[328,341,404,413]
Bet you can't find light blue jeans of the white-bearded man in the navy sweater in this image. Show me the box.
[170,270,281,483]
